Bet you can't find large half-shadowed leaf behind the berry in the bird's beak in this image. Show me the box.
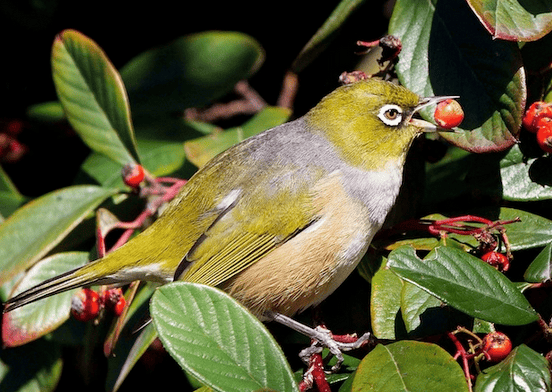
[389,0,526,152]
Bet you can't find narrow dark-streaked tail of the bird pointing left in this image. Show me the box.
[4,259,114,313]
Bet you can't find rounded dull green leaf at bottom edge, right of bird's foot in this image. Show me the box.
[351,341,468,392]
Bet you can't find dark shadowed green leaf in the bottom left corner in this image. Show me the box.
[0,339,63,392]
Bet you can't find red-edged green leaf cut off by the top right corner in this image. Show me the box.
[467,0,552,41]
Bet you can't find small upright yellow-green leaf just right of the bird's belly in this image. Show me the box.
[370,268,404,339]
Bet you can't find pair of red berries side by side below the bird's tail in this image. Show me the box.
[71,288,126,321]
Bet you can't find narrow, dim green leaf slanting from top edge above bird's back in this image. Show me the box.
[291,0,364,73]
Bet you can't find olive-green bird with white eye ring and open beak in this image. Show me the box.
[4,79,450,334]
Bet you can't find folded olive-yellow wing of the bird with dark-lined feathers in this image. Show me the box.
[175,163,322,286]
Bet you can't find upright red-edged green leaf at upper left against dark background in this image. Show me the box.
[52,30,140,165]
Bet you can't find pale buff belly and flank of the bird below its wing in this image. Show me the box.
[223,173,375,319]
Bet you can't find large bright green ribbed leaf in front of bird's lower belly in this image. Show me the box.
[151,282,298,392]
